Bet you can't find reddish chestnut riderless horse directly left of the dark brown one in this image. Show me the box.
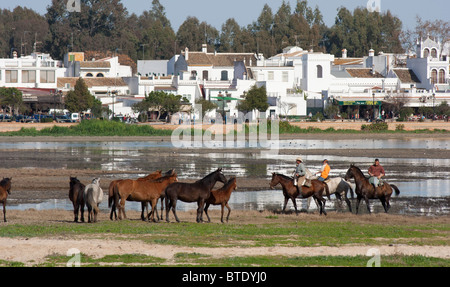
[114,172,177,221]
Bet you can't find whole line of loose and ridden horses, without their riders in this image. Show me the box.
[0,165,400,223]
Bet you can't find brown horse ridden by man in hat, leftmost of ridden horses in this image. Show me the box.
[270,173,330,215]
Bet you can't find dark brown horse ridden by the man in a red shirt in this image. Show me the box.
[345,164,400,214]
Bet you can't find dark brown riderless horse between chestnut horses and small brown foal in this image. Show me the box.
[165,168,227,222]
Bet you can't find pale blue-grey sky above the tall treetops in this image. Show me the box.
[0,0,450,32]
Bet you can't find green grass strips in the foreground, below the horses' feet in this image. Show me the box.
[0,219,450,267]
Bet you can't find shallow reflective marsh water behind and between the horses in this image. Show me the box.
[0,139,450,214]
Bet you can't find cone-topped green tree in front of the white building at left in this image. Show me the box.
[65,77,95,113]
